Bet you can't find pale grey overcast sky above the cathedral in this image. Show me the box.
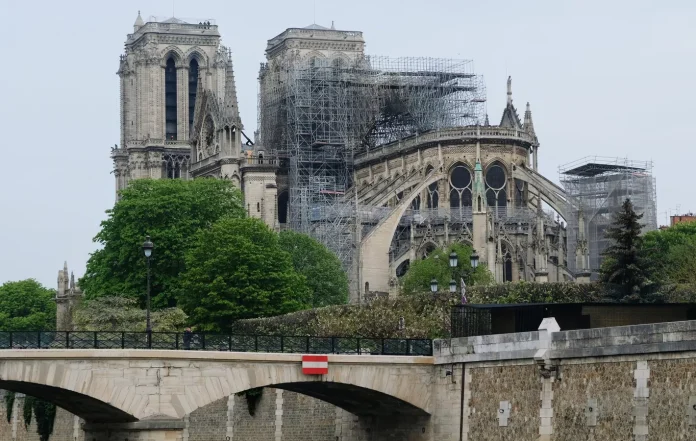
[0,0,696,287]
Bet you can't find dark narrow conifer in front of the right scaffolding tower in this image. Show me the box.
[600,199,651,302]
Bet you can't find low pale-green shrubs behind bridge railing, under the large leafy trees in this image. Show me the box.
[73,297,188,332]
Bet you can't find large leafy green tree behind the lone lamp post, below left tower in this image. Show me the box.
[80,179,244,309]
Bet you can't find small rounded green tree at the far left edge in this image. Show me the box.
[0,279,56,331]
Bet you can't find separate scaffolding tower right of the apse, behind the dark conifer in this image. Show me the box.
[559,156,657,280]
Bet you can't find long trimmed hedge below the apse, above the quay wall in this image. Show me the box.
[234,282,616,338]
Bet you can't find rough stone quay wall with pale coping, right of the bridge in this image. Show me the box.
[435,319,696,441]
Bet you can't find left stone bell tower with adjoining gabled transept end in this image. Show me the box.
[112,14,277,223]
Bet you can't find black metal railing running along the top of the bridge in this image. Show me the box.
[0,331,433,355]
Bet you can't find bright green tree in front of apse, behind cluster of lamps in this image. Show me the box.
[401,243,493,295]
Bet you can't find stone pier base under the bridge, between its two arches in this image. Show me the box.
[83,420,185,441]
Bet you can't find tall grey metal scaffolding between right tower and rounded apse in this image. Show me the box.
[259,55,485,284]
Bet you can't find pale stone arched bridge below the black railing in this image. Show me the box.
[0,349,434,441]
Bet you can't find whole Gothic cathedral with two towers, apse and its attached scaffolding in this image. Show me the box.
[111,14,590,302]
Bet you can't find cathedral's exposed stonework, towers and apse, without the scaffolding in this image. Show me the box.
[112,14,589,301]
